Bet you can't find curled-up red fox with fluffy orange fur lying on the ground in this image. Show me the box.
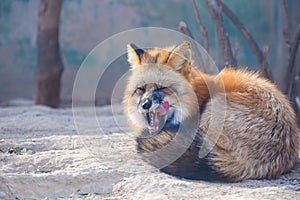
[123,42,299,182]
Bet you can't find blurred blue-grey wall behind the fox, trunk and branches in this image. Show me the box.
[0,0,300,108]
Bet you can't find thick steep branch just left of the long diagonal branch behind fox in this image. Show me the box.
[206,0,237,67]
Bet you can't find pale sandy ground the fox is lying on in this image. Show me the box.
[0,106,300,200]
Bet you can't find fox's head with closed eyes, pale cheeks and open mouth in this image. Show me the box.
[123,42,198,134]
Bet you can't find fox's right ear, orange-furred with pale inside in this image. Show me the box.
[167,42,192,70]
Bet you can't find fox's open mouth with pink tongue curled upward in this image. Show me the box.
[146,101,169,134]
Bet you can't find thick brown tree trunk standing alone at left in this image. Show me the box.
[35,0,63,107]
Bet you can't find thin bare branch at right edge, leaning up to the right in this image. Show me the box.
[287,23,300,97]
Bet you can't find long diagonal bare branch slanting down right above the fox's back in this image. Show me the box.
[217,0,273,80]
